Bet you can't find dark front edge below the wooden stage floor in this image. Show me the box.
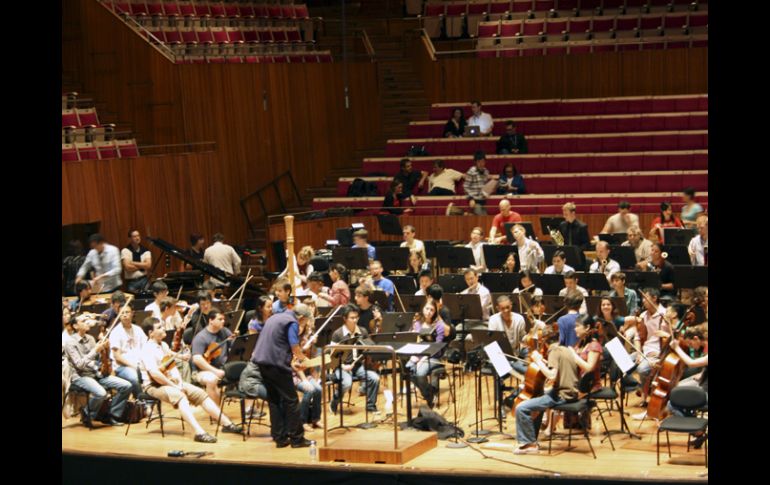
[62,451,704,485]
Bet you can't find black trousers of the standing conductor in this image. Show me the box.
[259,364,305,441]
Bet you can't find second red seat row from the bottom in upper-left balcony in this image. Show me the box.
[148,27,303,44]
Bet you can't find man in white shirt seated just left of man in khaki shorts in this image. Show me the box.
[109,306,147,398]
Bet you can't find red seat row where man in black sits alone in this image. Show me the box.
[385,130,708,157]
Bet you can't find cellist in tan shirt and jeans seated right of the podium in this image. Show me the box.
[514,334,579,454]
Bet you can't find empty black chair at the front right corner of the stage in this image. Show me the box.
[656,386,709,468]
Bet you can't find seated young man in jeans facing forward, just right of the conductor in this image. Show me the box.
[330,305,380,414]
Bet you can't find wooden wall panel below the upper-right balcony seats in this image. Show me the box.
[411,38,708,103]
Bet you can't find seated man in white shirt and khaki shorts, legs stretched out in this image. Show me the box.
[142,318,243,443]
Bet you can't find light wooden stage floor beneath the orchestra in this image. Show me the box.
[62,374,708,482]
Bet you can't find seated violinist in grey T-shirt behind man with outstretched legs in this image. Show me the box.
[191,308,233,402]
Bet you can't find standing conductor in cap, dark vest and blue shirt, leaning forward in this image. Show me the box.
[251,303,313,448]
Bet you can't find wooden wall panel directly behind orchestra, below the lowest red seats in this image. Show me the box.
[268,213,658,271]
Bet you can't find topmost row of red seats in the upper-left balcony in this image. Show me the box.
[102,0,310,19]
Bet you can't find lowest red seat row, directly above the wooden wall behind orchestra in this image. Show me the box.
[313,192,708,215]
